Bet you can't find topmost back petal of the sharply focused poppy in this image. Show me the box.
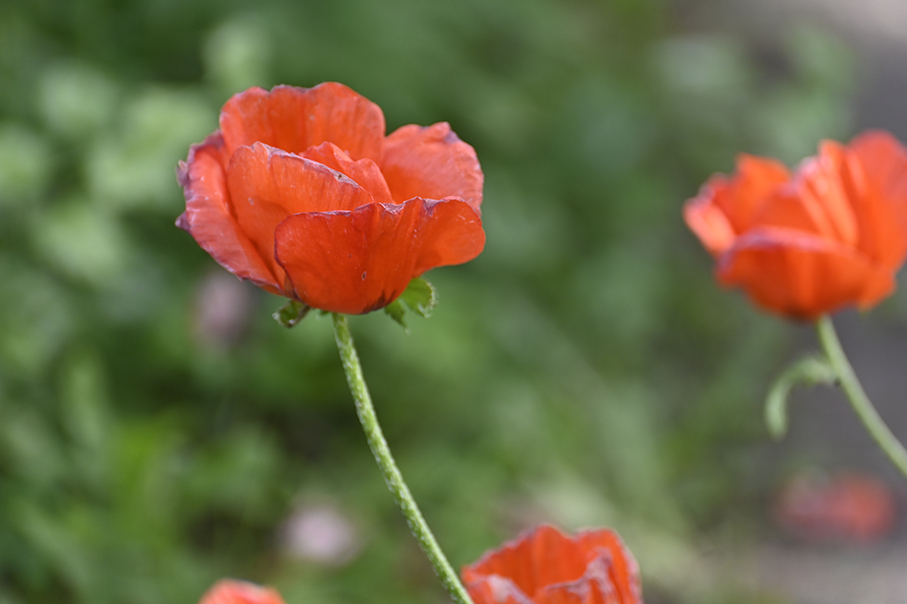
[220,82,385,161]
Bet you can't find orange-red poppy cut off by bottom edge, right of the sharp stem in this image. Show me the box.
[462,526,642,604]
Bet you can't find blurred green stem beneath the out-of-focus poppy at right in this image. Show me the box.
[816,315,907,478]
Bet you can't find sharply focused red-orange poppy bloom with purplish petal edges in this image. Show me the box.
[177,82,485,314]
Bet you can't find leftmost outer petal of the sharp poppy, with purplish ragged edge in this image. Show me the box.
[177,132,282,294]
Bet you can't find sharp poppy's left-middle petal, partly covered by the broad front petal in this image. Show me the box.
[227,143,372,295]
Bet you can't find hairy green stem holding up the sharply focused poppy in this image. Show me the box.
[333,313,472,604]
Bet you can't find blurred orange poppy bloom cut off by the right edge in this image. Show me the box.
[684,132,907,320]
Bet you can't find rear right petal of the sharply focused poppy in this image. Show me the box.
[380,122,485,212]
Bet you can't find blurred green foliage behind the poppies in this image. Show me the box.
[0,0,851,604]
